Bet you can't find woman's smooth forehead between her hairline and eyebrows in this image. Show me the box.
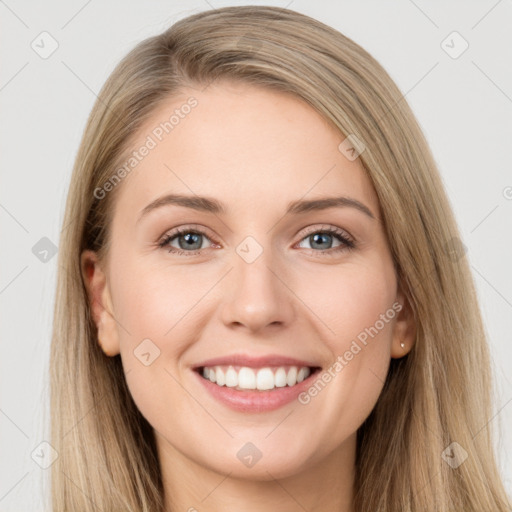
[110,82,378,222]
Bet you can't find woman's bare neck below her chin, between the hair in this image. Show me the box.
[159,434,356,512]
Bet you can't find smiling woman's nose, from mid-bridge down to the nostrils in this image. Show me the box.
[222,245,295,333]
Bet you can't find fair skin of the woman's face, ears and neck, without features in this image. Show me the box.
[82,82,414,512]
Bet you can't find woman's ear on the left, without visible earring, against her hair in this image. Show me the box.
[80,250,120,356]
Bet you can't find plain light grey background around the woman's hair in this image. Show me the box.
[0,0,512,512]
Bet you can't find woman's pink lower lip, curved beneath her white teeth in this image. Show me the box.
[194,370,319,412]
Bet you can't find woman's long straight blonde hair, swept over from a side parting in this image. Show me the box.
[50,6,509,512]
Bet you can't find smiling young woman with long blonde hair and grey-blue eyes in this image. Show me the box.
[51,6,509,512]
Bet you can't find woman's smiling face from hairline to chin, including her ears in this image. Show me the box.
[83,82,410,479]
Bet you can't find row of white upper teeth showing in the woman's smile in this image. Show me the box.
[199,366,311,391]
